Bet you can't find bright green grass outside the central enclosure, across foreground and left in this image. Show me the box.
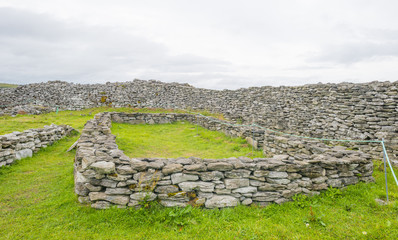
[0,110,398,239]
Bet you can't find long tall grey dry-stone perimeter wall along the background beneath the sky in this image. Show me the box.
[0,80,398,157]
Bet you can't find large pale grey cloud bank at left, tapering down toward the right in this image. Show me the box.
[0,8,231,84]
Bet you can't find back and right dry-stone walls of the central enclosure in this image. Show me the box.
[110,112,382,160]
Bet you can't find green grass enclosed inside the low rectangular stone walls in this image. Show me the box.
[112,122,263,158]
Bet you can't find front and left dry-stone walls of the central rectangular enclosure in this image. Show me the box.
[74,113,373,209]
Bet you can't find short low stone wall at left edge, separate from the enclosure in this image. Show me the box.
[0,124,74,167]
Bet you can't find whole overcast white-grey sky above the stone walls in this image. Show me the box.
[0,0,398,89]
